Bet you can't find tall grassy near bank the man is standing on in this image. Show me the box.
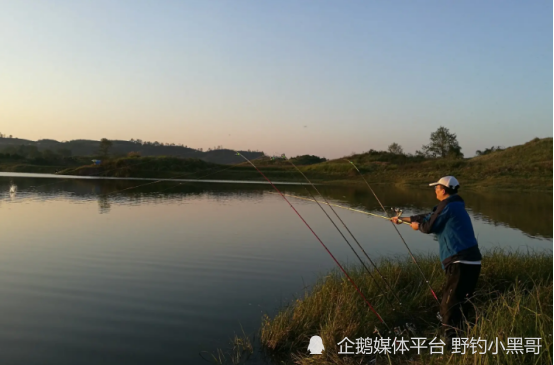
[260,251,553,365]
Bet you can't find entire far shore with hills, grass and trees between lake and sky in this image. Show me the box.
[0,127,552,191]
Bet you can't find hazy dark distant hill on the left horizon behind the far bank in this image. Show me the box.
[0,138,263,164]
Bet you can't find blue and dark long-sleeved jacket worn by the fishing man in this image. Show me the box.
[411,194,481,269]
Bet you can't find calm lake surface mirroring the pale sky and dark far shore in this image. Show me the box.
[0,174,552,365]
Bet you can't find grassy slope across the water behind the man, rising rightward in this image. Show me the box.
[305,138,552,191]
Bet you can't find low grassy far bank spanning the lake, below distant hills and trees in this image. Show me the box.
[0,137,553,193]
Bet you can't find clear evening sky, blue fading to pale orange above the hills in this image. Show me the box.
[0,0,553,158]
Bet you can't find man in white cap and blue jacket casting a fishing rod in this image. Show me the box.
[392,176,481,345]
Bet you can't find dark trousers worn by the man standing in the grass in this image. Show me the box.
[440,263,481,339]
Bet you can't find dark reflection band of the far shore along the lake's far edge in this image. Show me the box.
[0,178,553,238]
